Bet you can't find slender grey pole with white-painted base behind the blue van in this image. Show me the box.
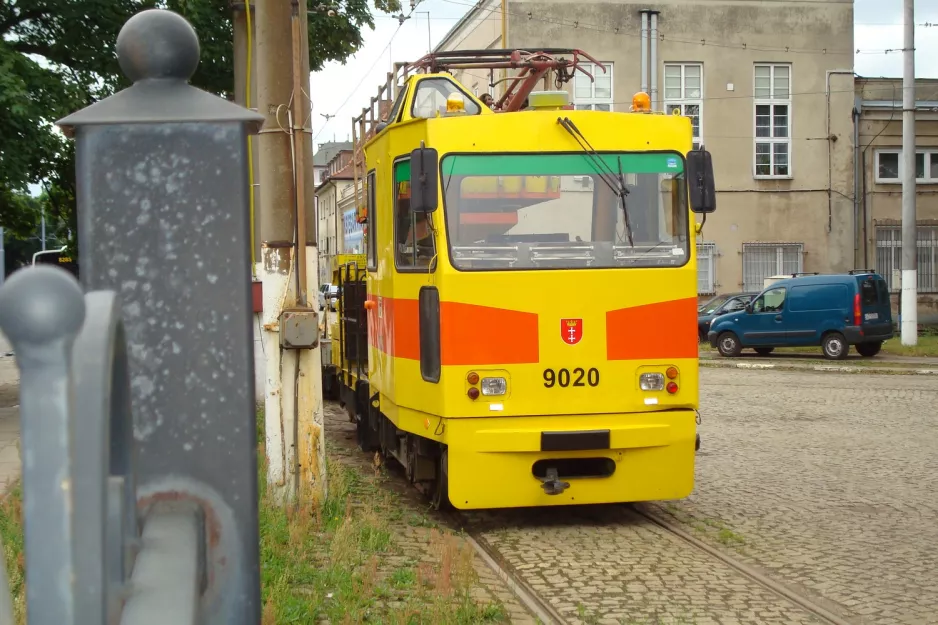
[900,0,918,345]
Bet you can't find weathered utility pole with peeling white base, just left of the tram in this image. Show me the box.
[255,0,326,500]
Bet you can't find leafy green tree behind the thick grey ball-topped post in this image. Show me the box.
[0,0,400,255]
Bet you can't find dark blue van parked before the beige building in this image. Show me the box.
[707,270,893,360]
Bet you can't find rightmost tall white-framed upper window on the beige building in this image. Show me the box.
[754,65,791,178]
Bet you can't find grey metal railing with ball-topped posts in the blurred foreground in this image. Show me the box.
[0,10,263,625]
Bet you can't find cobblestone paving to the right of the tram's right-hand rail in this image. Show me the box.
[662,369,938,625]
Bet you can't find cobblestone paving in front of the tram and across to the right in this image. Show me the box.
[336,369,938,625]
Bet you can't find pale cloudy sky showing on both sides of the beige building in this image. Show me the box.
[310,0,938,149]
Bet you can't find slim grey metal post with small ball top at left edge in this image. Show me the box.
[0,266,85,625]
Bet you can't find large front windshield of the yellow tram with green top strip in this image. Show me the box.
[441,152,689,270]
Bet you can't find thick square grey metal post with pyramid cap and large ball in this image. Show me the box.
[56,10,263,625]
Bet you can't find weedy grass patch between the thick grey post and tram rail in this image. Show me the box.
[260,454,506,625]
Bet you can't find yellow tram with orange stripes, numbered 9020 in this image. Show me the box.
[324,51,715,509]
